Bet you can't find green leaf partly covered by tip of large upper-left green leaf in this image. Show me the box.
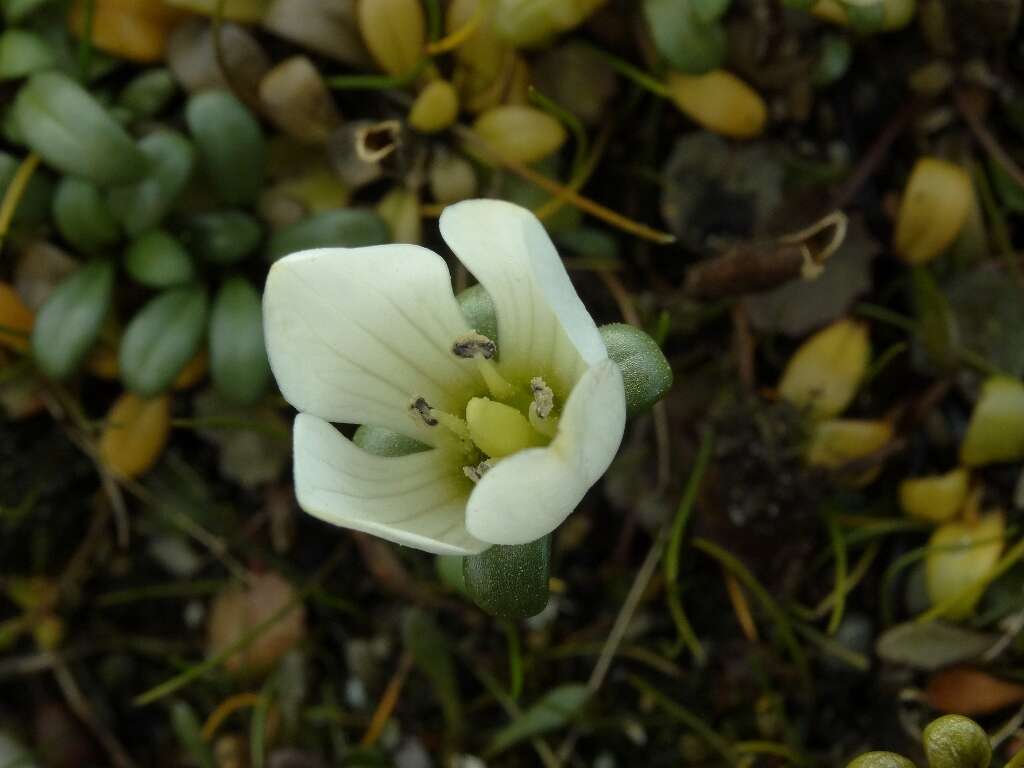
[109,129,196,237]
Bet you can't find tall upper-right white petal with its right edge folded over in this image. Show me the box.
[440,200,608,392]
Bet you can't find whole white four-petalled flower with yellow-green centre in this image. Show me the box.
[263,200,626,554]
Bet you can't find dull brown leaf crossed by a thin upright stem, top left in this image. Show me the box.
[167,18,270,102]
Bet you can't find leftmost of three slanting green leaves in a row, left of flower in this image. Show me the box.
[32,260,114,380]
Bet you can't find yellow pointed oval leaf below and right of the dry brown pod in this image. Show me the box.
[778,319,871,419]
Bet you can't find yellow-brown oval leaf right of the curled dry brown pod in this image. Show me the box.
[893,158,974,264]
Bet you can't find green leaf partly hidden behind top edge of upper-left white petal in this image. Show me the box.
[267,208,391,261]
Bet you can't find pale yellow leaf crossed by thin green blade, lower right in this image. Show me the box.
[925,511,1006,620]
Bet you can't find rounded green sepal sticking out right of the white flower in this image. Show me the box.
[598,323,673,417]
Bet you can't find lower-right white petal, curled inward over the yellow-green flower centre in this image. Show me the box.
[466,359,626,544]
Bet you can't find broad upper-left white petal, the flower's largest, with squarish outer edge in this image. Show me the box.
[263,245,478,444]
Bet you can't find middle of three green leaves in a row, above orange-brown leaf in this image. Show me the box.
[119,285,208,397]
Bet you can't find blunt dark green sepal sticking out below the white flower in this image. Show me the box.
[462,534,551,618]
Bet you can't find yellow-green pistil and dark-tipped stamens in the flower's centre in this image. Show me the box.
[410,333,558,482]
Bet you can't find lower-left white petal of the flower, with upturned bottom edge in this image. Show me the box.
[295,414,488,555]
